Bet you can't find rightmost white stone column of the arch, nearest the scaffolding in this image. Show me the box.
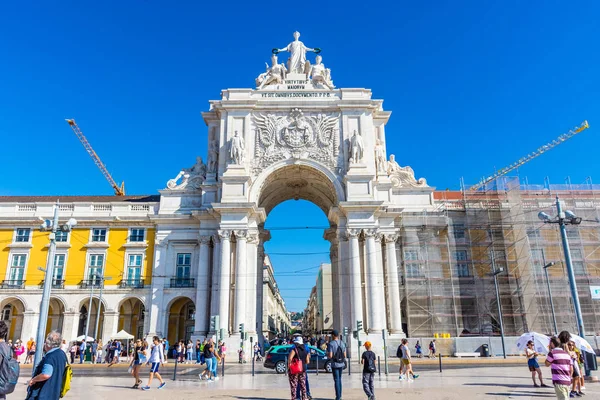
[384,234,402,333]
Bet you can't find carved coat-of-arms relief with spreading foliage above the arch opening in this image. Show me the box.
[252,108,339,174]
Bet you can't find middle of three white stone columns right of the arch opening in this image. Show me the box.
[364,229,385,333]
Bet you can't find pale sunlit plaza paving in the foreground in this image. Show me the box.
[14,363,600,400]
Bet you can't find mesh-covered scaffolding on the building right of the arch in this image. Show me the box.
[397,177,600,337]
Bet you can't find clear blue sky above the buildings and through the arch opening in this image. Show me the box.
[0,1,600,309]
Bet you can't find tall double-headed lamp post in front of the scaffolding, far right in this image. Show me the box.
[538,196,585,337]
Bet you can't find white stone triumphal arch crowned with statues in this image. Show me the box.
[150,32,433,350]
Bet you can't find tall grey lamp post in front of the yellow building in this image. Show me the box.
[32,206,77,373]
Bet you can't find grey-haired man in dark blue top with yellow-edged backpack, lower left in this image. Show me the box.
[26,331,68,400]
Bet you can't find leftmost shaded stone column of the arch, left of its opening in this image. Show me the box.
[194,236,210,336]
